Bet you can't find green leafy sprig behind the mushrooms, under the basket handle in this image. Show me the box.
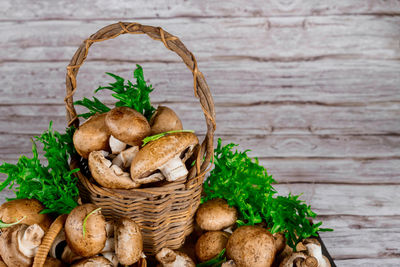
[74,65,155,120]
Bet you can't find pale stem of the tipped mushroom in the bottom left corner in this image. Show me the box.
[18,224,44,258]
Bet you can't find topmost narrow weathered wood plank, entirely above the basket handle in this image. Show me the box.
[0,0,400,20]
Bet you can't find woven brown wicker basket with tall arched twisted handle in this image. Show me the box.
[65,22,215,254]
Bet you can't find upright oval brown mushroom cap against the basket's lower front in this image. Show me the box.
[114,217,143,265]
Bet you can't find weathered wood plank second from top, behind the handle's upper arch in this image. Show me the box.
[0,16,400,62]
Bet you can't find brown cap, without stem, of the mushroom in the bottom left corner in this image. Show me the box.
[0,224,33,267]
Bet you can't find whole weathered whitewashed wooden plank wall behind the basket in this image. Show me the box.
[0,0,400,266]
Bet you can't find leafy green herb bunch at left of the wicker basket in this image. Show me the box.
[0,122,79,214]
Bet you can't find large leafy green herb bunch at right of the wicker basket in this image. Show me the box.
[202,139,332,248]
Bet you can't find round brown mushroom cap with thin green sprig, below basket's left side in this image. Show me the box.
[64,204,107,257]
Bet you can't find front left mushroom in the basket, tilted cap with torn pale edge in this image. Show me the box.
[89,151,140,189]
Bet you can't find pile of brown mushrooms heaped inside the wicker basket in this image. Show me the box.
[73,106,199,189]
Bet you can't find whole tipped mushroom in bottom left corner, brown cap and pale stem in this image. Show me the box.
[0,224,44,267]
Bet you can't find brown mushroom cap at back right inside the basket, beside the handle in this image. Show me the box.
[150,106,183,135]
